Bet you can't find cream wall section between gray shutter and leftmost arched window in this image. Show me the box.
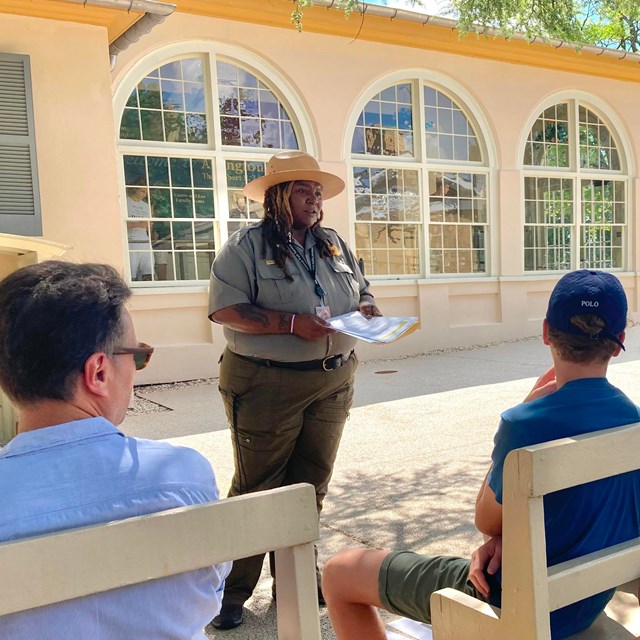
[0,14,123,271]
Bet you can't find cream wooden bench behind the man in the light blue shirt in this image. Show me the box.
[0,484,320,640]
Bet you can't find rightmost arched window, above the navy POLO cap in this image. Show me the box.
[523,100,627,271]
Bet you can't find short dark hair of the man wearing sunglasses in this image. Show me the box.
[0,260,131,402]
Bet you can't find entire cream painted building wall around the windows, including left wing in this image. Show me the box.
[0,14,640,383]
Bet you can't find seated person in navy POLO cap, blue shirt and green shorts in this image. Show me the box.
[322,270,640,640]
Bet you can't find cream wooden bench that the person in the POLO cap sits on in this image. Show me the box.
[431,423,640,640]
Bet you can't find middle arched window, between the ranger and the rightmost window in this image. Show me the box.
[351,78,489,277]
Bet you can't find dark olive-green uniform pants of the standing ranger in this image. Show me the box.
[220,349,358,604]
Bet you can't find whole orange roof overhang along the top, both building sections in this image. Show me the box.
[0,0,640,82]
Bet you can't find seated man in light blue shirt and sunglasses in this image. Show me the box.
[0,261,230,640]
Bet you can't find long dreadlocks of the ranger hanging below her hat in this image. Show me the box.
[262,182,340,281]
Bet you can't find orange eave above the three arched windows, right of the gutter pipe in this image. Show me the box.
[173,0,640,82]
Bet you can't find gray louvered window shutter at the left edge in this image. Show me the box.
[0,53,42,236]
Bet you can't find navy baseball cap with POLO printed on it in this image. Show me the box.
[547,269,627,349]
